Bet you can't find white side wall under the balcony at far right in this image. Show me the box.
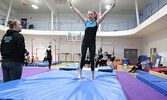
[141,28,167,66]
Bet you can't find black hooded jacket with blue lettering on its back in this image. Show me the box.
[1,30,27,63]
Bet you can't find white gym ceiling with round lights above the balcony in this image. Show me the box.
[1,0,152,13]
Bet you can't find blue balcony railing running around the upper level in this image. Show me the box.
[0,0,167,32]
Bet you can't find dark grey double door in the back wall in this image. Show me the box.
[124,49,138,62]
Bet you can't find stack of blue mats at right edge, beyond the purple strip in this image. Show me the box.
[136,70,167,96]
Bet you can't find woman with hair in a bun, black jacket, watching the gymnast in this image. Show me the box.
[1,20,27,82]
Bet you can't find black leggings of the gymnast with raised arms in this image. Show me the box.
[80,41,96,71]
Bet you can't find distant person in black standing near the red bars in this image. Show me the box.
[46,45,52,71]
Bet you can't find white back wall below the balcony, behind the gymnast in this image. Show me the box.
[24,35,141,61]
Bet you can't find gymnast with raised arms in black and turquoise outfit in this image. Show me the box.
[69,0,116,80]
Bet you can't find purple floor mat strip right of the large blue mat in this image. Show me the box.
[116,71,167,100]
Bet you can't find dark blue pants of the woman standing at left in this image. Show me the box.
[2,62,23,82]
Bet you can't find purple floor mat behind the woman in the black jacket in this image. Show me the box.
[0,67,47,78]
